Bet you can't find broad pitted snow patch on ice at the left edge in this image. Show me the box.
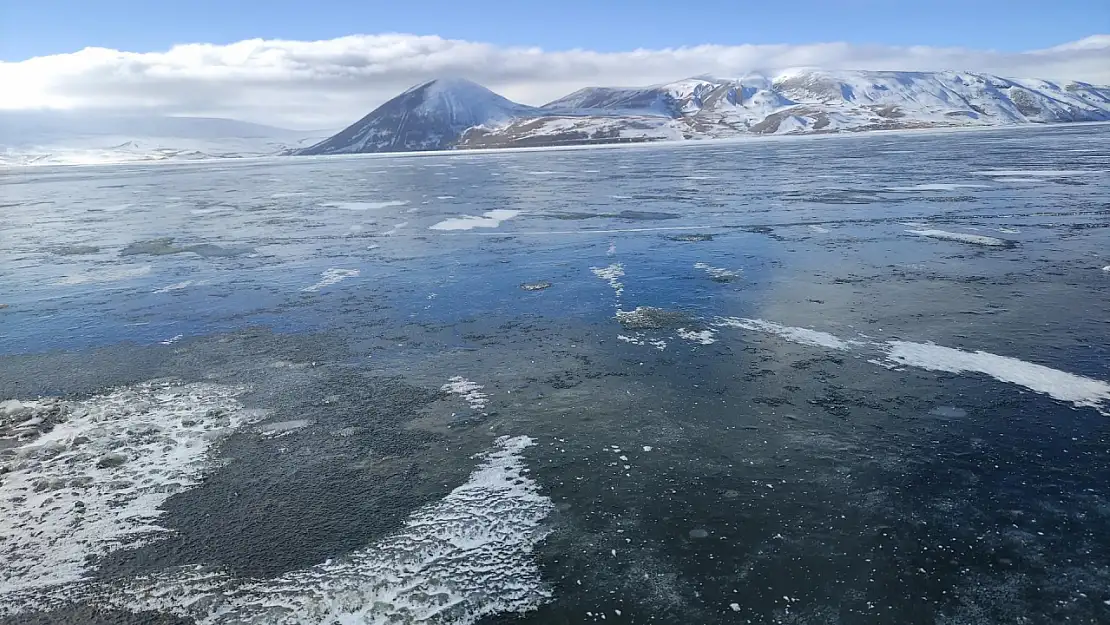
[0,382,262,604]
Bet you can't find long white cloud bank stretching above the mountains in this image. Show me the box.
[0,34,1110,128]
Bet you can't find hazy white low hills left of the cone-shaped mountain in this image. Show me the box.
[0,111,330,165]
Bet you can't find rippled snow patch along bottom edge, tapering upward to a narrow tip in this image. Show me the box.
[0,436,554,625]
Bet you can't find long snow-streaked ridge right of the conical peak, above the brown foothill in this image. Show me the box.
[539,69,1110,138]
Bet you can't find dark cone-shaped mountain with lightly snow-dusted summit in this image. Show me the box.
[296,79,539,154]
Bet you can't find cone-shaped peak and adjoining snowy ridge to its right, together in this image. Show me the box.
[297,69,1110,154]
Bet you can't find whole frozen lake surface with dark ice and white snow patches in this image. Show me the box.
[0,125,1110,625]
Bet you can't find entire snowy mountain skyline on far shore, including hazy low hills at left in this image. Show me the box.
[17,69,1110,167]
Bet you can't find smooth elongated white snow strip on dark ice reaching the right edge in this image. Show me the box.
[887,341,1110,414]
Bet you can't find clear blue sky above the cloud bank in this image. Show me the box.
[0,0,1110,61]
